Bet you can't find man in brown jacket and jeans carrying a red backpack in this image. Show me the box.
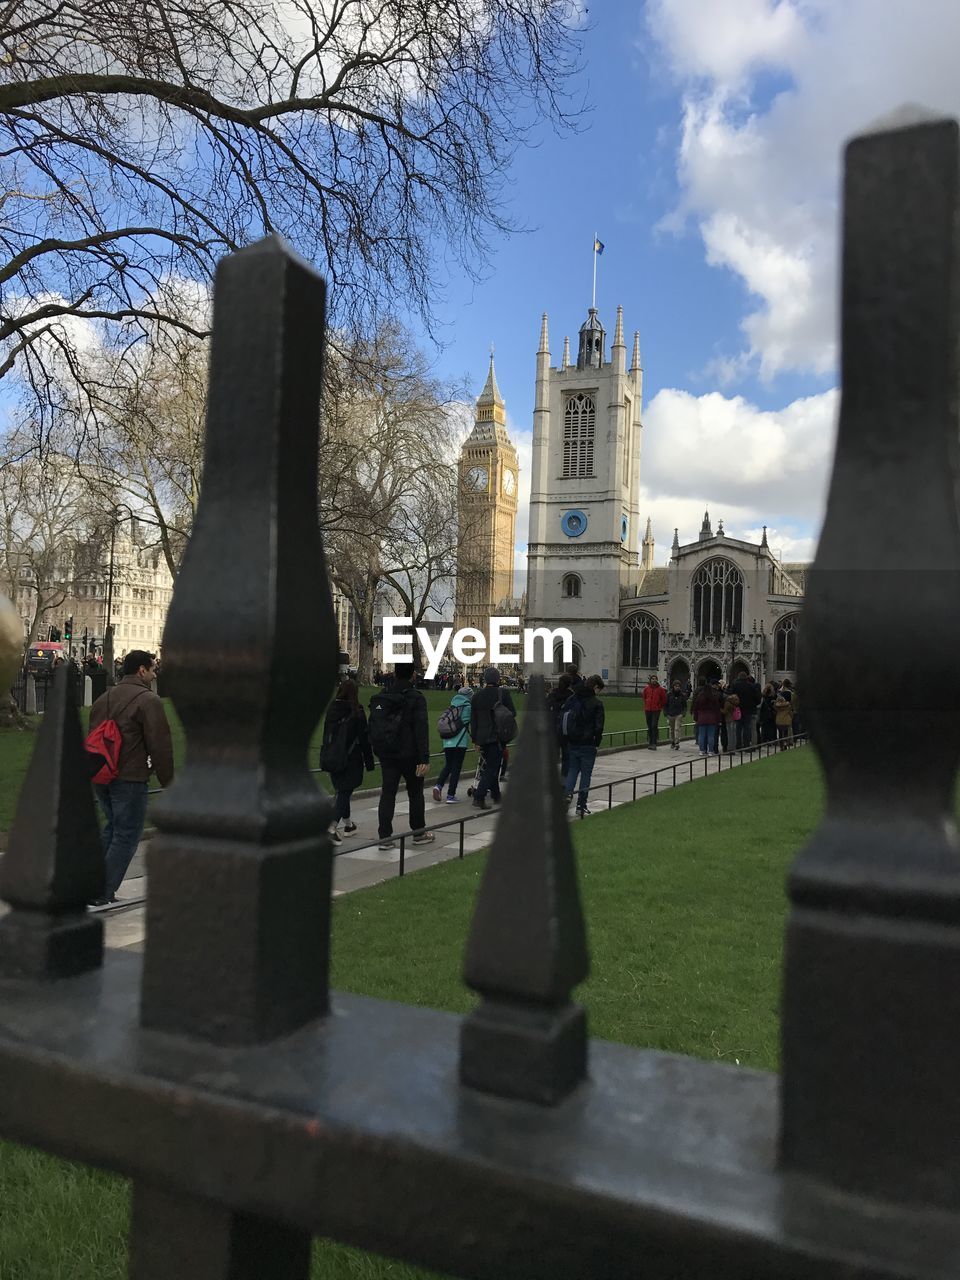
[90,649,173,906]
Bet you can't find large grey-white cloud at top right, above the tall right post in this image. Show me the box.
[648,0,960,379]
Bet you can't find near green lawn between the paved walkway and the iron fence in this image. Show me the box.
[0,749,823,1280]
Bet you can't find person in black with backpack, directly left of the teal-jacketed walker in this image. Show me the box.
[369,662,436,849]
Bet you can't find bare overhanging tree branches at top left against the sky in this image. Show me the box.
[0,0,577,440]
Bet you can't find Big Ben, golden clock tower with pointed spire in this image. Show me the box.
[456,353,518,635]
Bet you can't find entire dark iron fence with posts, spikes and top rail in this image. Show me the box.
[0,115,960,1280]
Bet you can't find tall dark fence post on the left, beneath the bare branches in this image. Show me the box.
[141,237,338,1043]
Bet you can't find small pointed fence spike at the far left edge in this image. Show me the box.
[0,663,104,978]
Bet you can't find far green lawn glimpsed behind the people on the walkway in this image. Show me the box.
[0,686,691,834]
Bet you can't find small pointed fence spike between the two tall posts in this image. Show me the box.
[460,676,590,1105]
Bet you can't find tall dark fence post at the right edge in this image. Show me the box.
[781,110,960,1210]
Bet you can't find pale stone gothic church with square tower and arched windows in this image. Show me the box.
[525,307,806,692]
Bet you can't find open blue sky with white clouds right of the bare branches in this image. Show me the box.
[407,0,960,563]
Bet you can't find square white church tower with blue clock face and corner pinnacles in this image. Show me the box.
[526,307,643,678]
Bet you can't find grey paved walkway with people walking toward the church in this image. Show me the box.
[102,741,798,950]
